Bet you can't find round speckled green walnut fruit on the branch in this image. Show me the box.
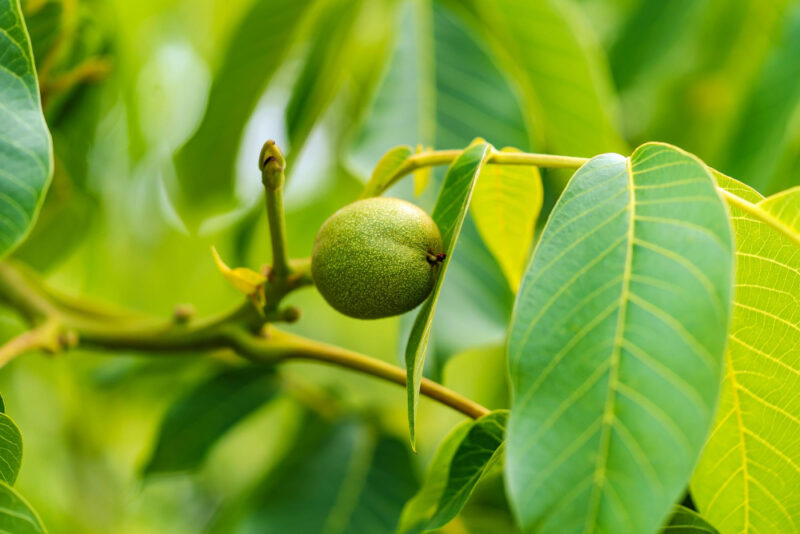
[311,197,445,319]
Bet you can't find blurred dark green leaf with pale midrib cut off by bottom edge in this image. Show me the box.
[233,420,416,534]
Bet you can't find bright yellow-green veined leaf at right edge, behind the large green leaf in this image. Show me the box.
[692,174,800,534]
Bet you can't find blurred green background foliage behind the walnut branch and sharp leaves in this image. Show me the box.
[6,0,800,533]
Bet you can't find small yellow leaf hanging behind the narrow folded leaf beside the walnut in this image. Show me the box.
[471,148,543,292]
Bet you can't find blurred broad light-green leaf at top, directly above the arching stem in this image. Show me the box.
[458,0,625,156]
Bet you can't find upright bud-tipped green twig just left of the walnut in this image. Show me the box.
[258,140,291,280]
